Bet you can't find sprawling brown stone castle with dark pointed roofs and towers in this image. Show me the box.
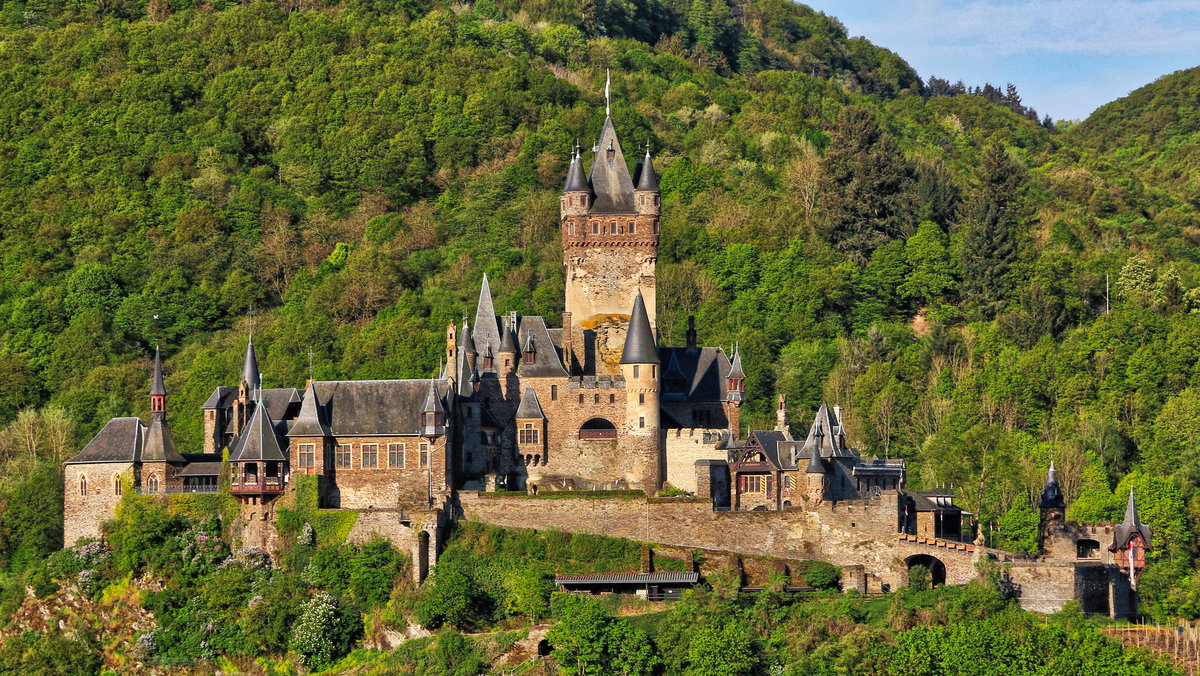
[64,97,1150,615]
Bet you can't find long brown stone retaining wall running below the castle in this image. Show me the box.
[458,492,907,586]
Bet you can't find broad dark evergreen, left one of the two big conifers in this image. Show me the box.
[818,106,917,265]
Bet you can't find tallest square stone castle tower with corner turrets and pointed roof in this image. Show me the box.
[559,102,661,375]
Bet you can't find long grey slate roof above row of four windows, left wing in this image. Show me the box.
[312,379,449,437]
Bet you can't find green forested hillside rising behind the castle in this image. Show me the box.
[0,0,1200,612]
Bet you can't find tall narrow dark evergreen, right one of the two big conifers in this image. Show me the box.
[960,140,1025,317]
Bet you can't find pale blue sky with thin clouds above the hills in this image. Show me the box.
[804,0,1200,120]
